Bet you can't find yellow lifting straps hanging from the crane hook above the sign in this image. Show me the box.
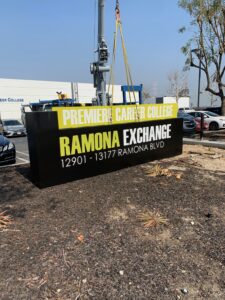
[108,0,139,108]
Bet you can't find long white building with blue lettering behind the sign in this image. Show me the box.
[0,78,134,119]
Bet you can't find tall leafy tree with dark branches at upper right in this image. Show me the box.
[178,0,225,115]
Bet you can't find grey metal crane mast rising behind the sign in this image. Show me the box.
[91,0,110,105]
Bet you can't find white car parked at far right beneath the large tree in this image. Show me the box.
[189,111,225,130]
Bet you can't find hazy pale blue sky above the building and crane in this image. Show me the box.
[0,0,215,103]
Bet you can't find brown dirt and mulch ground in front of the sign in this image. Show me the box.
[0,146,225,300]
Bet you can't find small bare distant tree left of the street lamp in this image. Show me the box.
[168,71,189,102]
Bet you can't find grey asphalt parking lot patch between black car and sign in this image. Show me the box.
[0,137,30,168]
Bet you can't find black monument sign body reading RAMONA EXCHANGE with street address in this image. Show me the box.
[26,112,182,187]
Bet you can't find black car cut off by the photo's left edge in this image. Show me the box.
[0,134,16,166]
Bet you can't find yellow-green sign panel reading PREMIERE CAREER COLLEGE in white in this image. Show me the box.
[52,103,178,129]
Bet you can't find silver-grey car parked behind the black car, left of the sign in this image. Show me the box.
[2,119,27,137]
